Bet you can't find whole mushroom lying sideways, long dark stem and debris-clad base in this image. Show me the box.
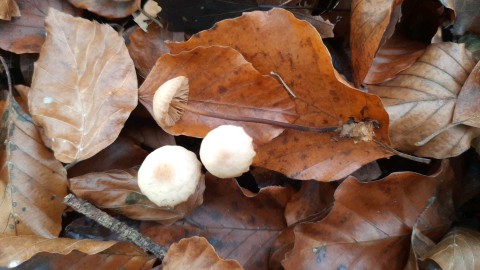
[153,76,430,163]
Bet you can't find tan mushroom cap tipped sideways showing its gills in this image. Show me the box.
[153,76,189,128]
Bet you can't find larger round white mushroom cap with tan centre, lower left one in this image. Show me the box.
[138,145,202,207]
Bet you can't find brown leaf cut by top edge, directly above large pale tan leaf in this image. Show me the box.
[68,0,140,19]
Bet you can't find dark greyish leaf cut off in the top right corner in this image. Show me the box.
[440,0,480,35]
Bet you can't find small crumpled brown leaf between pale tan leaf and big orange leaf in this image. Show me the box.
[127,24,185,78]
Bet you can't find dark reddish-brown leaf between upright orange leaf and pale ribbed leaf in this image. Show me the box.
[364,35,428,84]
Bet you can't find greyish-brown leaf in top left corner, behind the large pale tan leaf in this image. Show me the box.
[0,0,78,54]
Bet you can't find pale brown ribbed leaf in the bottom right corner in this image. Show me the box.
[421,227,480,270]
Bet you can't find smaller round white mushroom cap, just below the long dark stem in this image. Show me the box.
[200,125,256,178]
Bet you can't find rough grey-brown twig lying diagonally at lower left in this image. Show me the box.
[63,194,167,260]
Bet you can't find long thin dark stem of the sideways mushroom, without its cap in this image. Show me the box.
[170,100,339,133]
